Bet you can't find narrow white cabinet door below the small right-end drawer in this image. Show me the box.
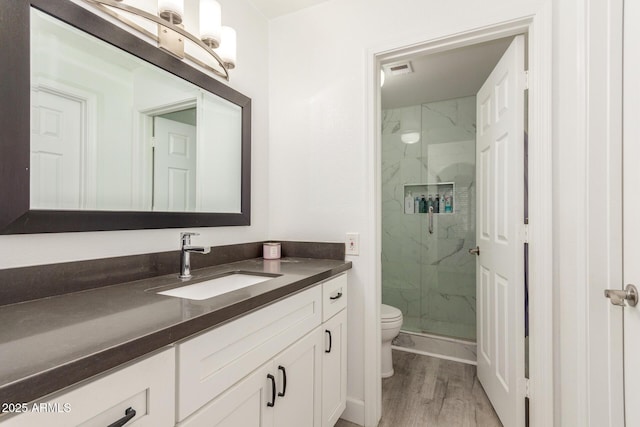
[322,310,347,427]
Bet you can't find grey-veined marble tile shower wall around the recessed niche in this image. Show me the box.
[382,96,476,340]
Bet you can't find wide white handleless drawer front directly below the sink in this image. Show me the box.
[177,286,322,421]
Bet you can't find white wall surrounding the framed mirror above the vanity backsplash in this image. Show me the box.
[0,0,269,269]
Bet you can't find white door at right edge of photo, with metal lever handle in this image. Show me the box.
[622,0,640,427]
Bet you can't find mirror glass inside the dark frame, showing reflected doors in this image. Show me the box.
[30,9,242,213]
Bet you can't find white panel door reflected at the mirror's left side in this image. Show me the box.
[30,90,84,209]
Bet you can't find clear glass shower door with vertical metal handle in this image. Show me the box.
[420,96,476,341]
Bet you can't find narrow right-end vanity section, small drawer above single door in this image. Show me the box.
[322,274,347,427]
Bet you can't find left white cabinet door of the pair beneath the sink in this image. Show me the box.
[178,362,276,427]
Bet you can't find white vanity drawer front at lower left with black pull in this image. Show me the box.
[0,348,175,427]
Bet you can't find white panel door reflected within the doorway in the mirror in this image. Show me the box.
[153,117,197,212]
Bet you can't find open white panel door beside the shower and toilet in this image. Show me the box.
[476,36,524,427]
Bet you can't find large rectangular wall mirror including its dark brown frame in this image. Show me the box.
[0,0,251,234]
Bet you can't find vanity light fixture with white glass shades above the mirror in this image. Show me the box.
[82,0,236,80]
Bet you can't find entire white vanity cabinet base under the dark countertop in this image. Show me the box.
[0,274,347,427]
